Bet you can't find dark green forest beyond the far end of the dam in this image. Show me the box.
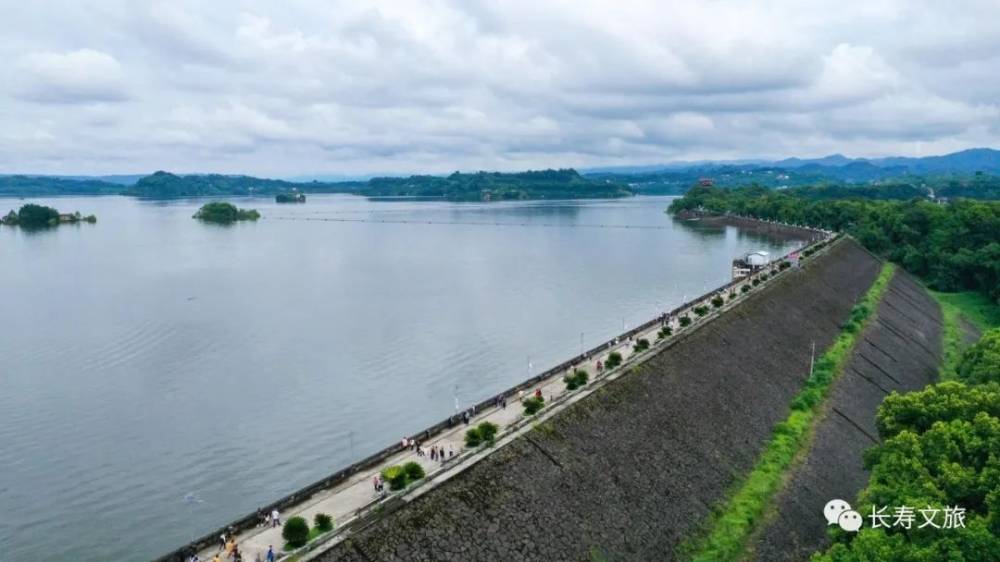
[670,187,1000,301]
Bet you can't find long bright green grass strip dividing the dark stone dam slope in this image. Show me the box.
[680,263,895,561]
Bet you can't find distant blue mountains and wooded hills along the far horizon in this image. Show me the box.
[0,148,1000,200]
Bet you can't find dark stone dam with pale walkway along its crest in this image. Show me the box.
[161,230,940,562]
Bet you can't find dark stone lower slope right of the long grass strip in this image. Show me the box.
[754,270,942,561]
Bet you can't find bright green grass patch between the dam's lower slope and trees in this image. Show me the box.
[927,290,1000,380]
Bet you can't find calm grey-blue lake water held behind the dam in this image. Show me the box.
[0,191,798,562]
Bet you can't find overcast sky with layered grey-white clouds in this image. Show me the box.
[0,0,1000,177]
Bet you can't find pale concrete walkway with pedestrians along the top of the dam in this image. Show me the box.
[189,252,812,562]
